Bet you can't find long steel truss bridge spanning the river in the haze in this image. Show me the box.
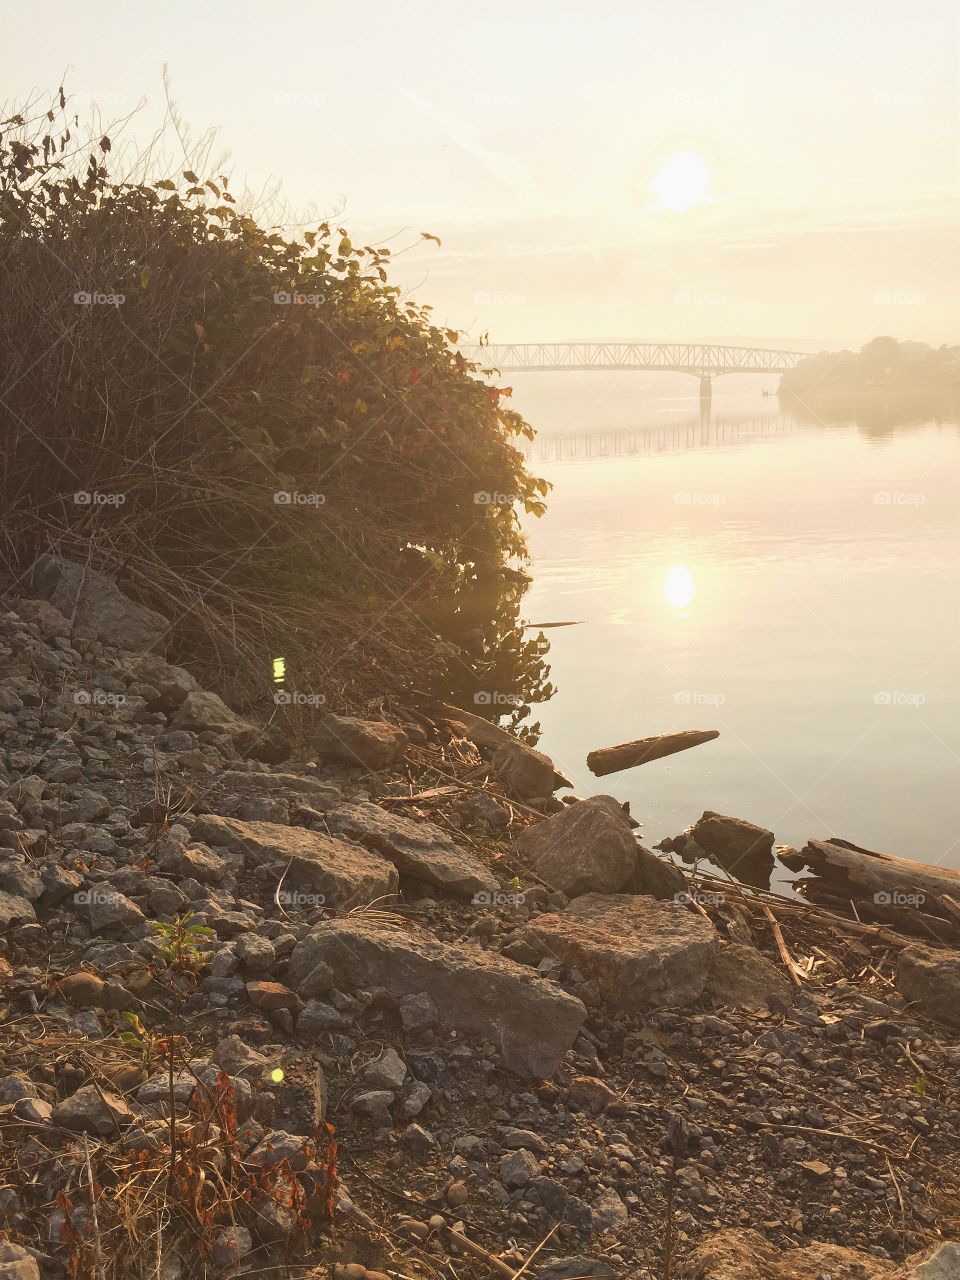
[462,342,809,393]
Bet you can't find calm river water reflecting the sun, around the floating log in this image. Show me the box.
[515,374,960,867]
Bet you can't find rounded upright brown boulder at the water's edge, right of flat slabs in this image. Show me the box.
[515,796,686,897]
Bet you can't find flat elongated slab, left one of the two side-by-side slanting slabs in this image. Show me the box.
[192,814,399,911]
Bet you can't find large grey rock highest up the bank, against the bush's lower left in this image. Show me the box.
[29,556,170,652]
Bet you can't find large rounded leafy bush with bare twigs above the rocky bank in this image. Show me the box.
[0,91,547,701]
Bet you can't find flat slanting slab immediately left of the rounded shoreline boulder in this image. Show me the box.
[326,804,499,895]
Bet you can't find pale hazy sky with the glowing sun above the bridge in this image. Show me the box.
[0,0,960,346]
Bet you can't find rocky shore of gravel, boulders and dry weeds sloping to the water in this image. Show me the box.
[0,559,960,1280]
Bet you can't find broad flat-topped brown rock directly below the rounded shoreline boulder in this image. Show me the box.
[521,893,717,1010]
